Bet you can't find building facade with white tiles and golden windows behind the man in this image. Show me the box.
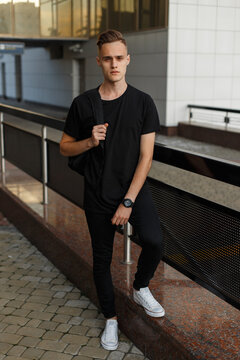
[0,0,240,133]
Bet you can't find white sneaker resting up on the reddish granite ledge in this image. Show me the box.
[133,287,165,317]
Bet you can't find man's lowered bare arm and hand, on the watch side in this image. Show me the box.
[112,132,155,225]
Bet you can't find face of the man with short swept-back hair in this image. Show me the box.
[97,41,130,82]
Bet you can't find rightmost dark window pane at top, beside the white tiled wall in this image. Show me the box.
[139,0,167,30]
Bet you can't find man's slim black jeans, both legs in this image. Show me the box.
[85,185,163,318]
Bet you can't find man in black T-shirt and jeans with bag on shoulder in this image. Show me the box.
[60,30,165,350]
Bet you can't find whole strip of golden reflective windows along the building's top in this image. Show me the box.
[0,0,168,38]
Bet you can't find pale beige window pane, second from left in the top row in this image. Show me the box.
[13,0,40,36]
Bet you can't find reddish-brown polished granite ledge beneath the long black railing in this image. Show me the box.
[0,188,240,360]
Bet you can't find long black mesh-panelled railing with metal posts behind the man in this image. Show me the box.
[0,104,240,308]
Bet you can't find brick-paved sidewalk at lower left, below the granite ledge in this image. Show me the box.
[0,213,149,360]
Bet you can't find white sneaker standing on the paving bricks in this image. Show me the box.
[101,319,118,350]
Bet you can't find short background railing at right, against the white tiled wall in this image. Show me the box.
[188,105,240,130]
